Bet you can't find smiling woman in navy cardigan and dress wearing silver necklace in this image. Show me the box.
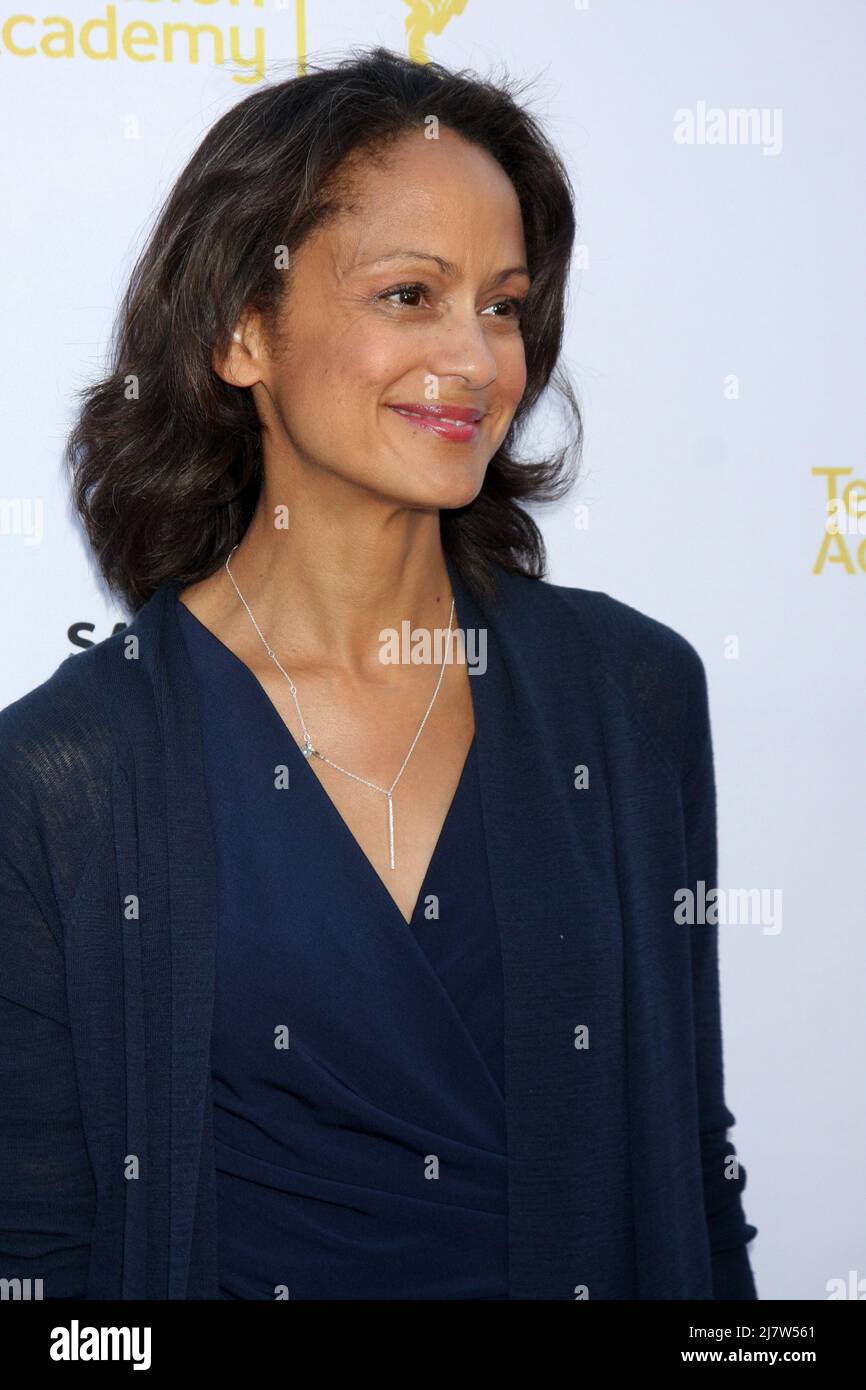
[0,49,756,1300]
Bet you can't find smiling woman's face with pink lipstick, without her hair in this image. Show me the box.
[234,129,530,507]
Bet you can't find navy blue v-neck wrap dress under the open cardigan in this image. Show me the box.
[178,602,509,1300]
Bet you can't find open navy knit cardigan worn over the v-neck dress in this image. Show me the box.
[0,560,758,1300]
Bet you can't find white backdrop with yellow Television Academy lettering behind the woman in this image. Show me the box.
[0,0,866,1300]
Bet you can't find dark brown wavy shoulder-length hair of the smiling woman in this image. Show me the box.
[64,47,584,613]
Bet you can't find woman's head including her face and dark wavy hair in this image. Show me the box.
[68,50,582,610]
